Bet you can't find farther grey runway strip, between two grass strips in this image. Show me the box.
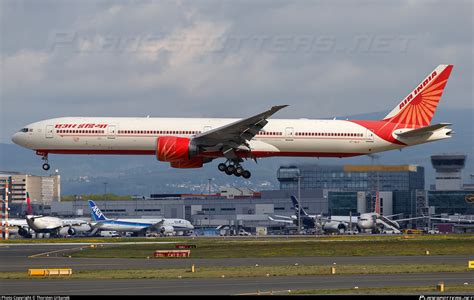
[0,244,474,272]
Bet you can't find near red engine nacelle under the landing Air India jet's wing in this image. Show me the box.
[156,136,198,162]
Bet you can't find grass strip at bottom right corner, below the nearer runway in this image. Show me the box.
[288,285,474,295]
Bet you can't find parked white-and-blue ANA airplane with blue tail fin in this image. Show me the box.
[89,200,194,235]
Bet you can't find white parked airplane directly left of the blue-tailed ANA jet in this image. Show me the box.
[24,215,92,237]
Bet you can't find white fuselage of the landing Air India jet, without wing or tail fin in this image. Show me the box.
[12,117,446,157]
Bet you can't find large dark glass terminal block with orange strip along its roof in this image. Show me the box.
[277,164,426,217]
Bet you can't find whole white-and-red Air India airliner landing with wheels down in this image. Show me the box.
[12,65,453,178]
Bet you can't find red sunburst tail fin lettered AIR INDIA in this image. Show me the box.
[383,65,453,128]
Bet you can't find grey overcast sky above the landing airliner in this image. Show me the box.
[0,0,474,142]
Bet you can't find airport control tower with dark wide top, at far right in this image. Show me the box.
[431,154,466,191]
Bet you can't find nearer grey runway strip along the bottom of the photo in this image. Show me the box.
[0,273,474,295]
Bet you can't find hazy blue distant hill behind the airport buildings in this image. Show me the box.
[0,108,474,195]
